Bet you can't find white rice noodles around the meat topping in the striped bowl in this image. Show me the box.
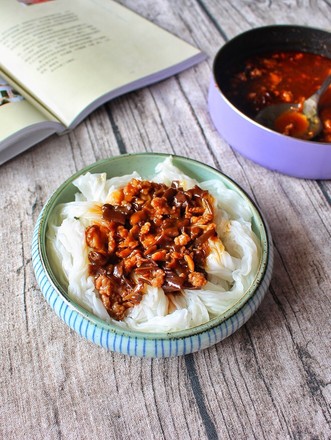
[48,157,261,332]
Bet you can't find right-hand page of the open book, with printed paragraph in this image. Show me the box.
[0,0,203,126]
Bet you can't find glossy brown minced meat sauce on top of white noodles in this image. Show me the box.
[85,179,217,320]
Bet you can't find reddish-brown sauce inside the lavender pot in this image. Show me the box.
[223,51,331,142]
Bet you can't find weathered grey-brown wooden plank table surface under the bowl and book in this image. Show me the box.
[0,0,331,440]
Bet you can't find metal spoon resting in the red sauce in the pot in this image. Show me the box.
[255,75,331,140]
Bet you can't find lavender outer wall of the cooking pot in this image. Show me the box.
[208,77,331,179]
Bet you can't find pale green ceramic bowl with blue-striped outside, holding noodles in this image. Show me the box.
[32,153,273,357]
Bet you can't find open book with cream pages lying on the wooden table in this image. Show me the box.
[0,0,205,164]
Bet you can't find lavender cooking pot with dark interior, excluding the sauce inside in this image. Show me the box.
[208,25,331,179]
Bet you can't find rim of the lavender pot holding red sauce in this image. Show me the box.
[212,24,331,148]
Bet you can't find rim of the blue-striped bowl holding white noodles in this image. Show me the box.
[37,152,272,340]
